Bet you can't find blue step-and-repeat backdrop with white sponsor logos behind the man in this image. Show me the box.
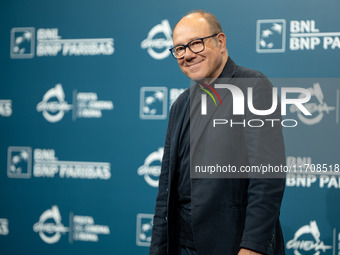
[0,0,340,255]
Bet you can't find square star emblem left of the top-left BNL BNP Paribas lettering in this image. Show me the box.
[10,27,35,58]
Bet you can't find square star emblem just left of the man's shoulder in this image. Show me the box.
[139,87,168,120]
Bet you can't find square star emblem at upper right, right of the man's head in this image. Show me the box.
[256,19,286,53]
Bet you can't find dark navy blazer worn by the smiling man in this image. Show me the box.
[150,58,285,255]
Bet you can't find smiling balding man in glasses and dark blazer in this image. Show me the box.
[150,10,285,255]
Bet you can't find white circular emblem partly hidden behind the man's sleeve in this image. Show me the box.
[137,148,164,187]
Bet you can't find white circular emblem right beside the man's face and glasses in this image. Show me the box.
[141,19,172,60]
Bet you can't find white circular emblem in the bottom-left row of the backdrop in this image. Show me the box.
[33,205,68,244]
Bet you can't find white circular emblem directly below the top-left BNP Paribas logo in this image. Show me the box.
[37,84,72,122]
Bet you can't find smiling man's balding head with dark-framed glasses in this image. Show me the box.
[172,13,228,83]
